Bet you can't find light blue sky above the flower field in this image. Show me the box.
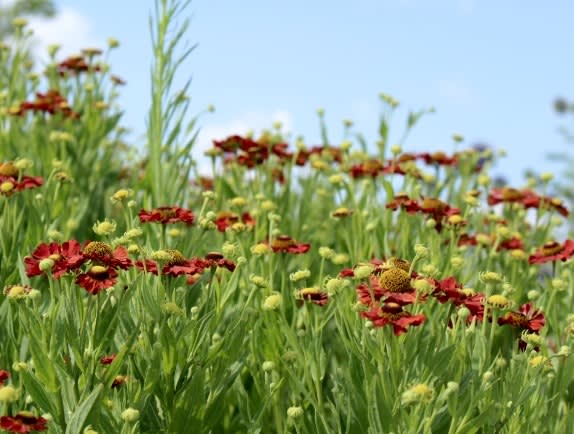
[28,0,574,185]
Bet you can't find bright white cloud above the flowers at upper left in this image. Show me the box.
[29,7,101,60]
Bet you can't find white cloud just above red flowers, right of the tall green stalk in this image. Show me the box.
[193,109,293,173]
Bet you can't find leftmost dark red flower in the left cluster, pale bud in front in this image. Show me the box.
[24,240,84,279]
